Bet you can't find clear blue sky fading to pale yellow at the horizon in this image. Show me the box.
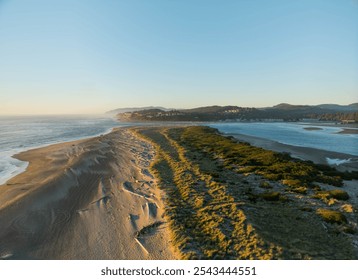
[0,0,358,114]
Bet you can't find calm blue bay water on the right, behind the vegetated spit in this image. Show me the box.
[209,122,358,156]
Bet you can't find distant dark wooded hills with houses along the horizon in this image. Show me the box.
[117,103,358,122]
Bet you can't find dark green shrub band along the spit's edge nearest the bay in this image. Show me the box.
[180,127,358,185]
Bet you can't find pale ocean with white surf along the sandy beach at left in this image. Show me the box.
[0,116,126,185]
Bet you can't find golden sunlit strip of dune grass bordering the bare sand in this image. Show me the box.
[139,129,280,259]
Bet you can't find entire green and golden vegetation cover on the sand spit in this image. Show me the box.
[136,126,356,259]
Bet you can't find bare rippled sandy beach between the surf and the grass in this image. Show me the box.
[0,129,177,260]
